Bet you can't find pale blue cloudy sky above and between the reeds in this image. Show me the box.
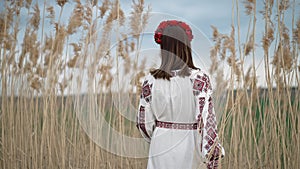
[0,0,300,90]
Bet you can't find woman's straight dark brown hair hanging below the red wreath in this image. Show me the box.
[150,25,198,80]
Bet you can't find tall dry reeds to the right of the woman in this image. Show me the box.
[210,0,300,168]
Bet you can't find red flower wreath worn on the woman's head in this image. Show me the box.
[154,20,194,44]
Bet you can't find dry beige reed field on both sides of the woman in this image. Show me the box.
[0,0,300,169]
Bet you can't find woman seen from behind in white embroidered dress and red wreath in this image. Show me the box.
[137,20,224,169]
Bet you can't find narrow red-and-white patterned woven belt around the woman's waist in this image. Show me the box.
[155,121,197,130]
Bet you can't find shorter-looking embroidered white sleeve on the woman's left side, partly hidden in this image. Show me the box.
[137,76,155,142]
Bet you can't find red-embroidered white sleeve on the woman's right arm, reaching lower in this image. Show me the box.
[192,72,225,169]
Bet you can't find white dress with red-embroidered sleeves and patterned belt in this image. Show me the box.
[137,69,224,169]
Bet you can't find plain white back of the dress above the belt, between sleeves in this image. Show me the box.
[152,70,196,123]
